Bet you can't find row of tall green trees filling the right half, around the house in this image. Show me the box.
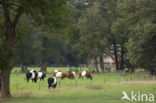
[70,0,156,75]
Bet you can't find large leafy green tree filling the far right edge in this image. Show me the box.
[118,0,156,75]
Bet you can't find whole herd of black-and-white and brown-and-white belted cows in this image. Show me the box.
[26,70,92,88]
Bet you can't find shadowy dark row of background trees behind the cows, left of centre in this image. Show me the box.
[14,28,79,72]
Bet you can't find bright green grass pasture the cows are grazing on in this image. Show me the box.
[0,68,156,103]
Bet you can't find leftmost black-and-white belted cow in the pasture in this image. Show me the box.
[26,70,38,83]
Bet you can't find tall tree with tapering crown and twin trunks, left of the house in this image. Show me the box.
[76,2,108,72]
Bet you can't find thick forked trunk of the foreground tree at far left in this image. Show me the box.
[1,0,24,98]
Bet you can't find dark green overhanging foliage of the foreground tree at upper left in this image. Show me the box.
[0,0,71,72]
